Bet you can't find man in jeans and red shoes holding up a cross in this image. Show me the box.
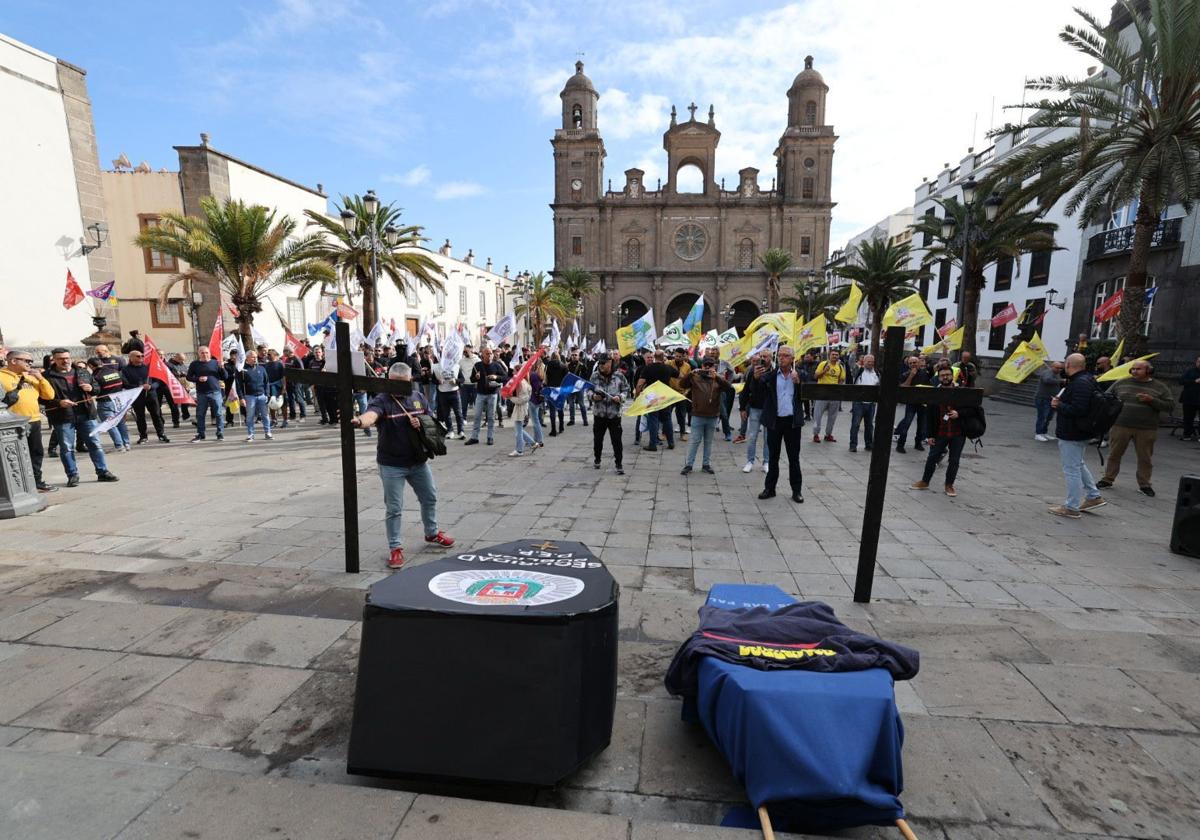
[350,360,456,569]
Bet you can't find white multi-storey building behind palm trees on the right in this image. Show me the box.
[912,130,1081,360]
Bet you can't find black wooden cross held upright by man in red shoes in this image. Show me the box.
[283,320,413,574]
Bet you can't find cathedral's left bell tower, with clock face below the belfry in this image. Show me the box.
[551,61,605,204]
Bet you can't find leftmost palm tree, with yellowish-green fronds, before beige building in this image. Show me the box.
[133,196,337,349]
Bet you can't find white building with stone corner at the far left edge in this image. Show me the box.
[0,35,113,348]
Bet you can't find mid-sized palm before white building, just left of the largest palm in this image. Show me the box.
[912,184,1060,356]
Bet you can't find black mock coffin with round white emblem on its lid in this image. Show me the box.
[347,540,618,785]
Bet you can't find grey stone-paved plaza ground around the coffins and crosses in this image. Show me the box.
[0,402,1200,840]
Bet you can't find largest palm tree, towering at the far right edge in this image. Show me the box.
[996,0,1200,355]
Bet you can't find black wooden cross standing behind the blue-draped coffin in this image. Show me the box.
[800,326,983,604]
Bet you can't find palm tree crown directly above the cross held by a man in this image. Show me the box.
[300,196,444,329]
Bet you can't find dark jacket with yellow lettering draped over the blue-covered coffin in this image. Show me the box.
[666,601,920,696]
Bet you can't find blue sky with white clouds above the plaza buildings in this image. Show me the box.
[0,0,1110,271]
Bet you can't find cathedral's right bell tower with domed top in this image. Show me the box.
[775,55,838,206]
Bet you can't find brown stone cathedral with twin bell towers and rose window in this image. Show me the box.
[551,56,838,344]
